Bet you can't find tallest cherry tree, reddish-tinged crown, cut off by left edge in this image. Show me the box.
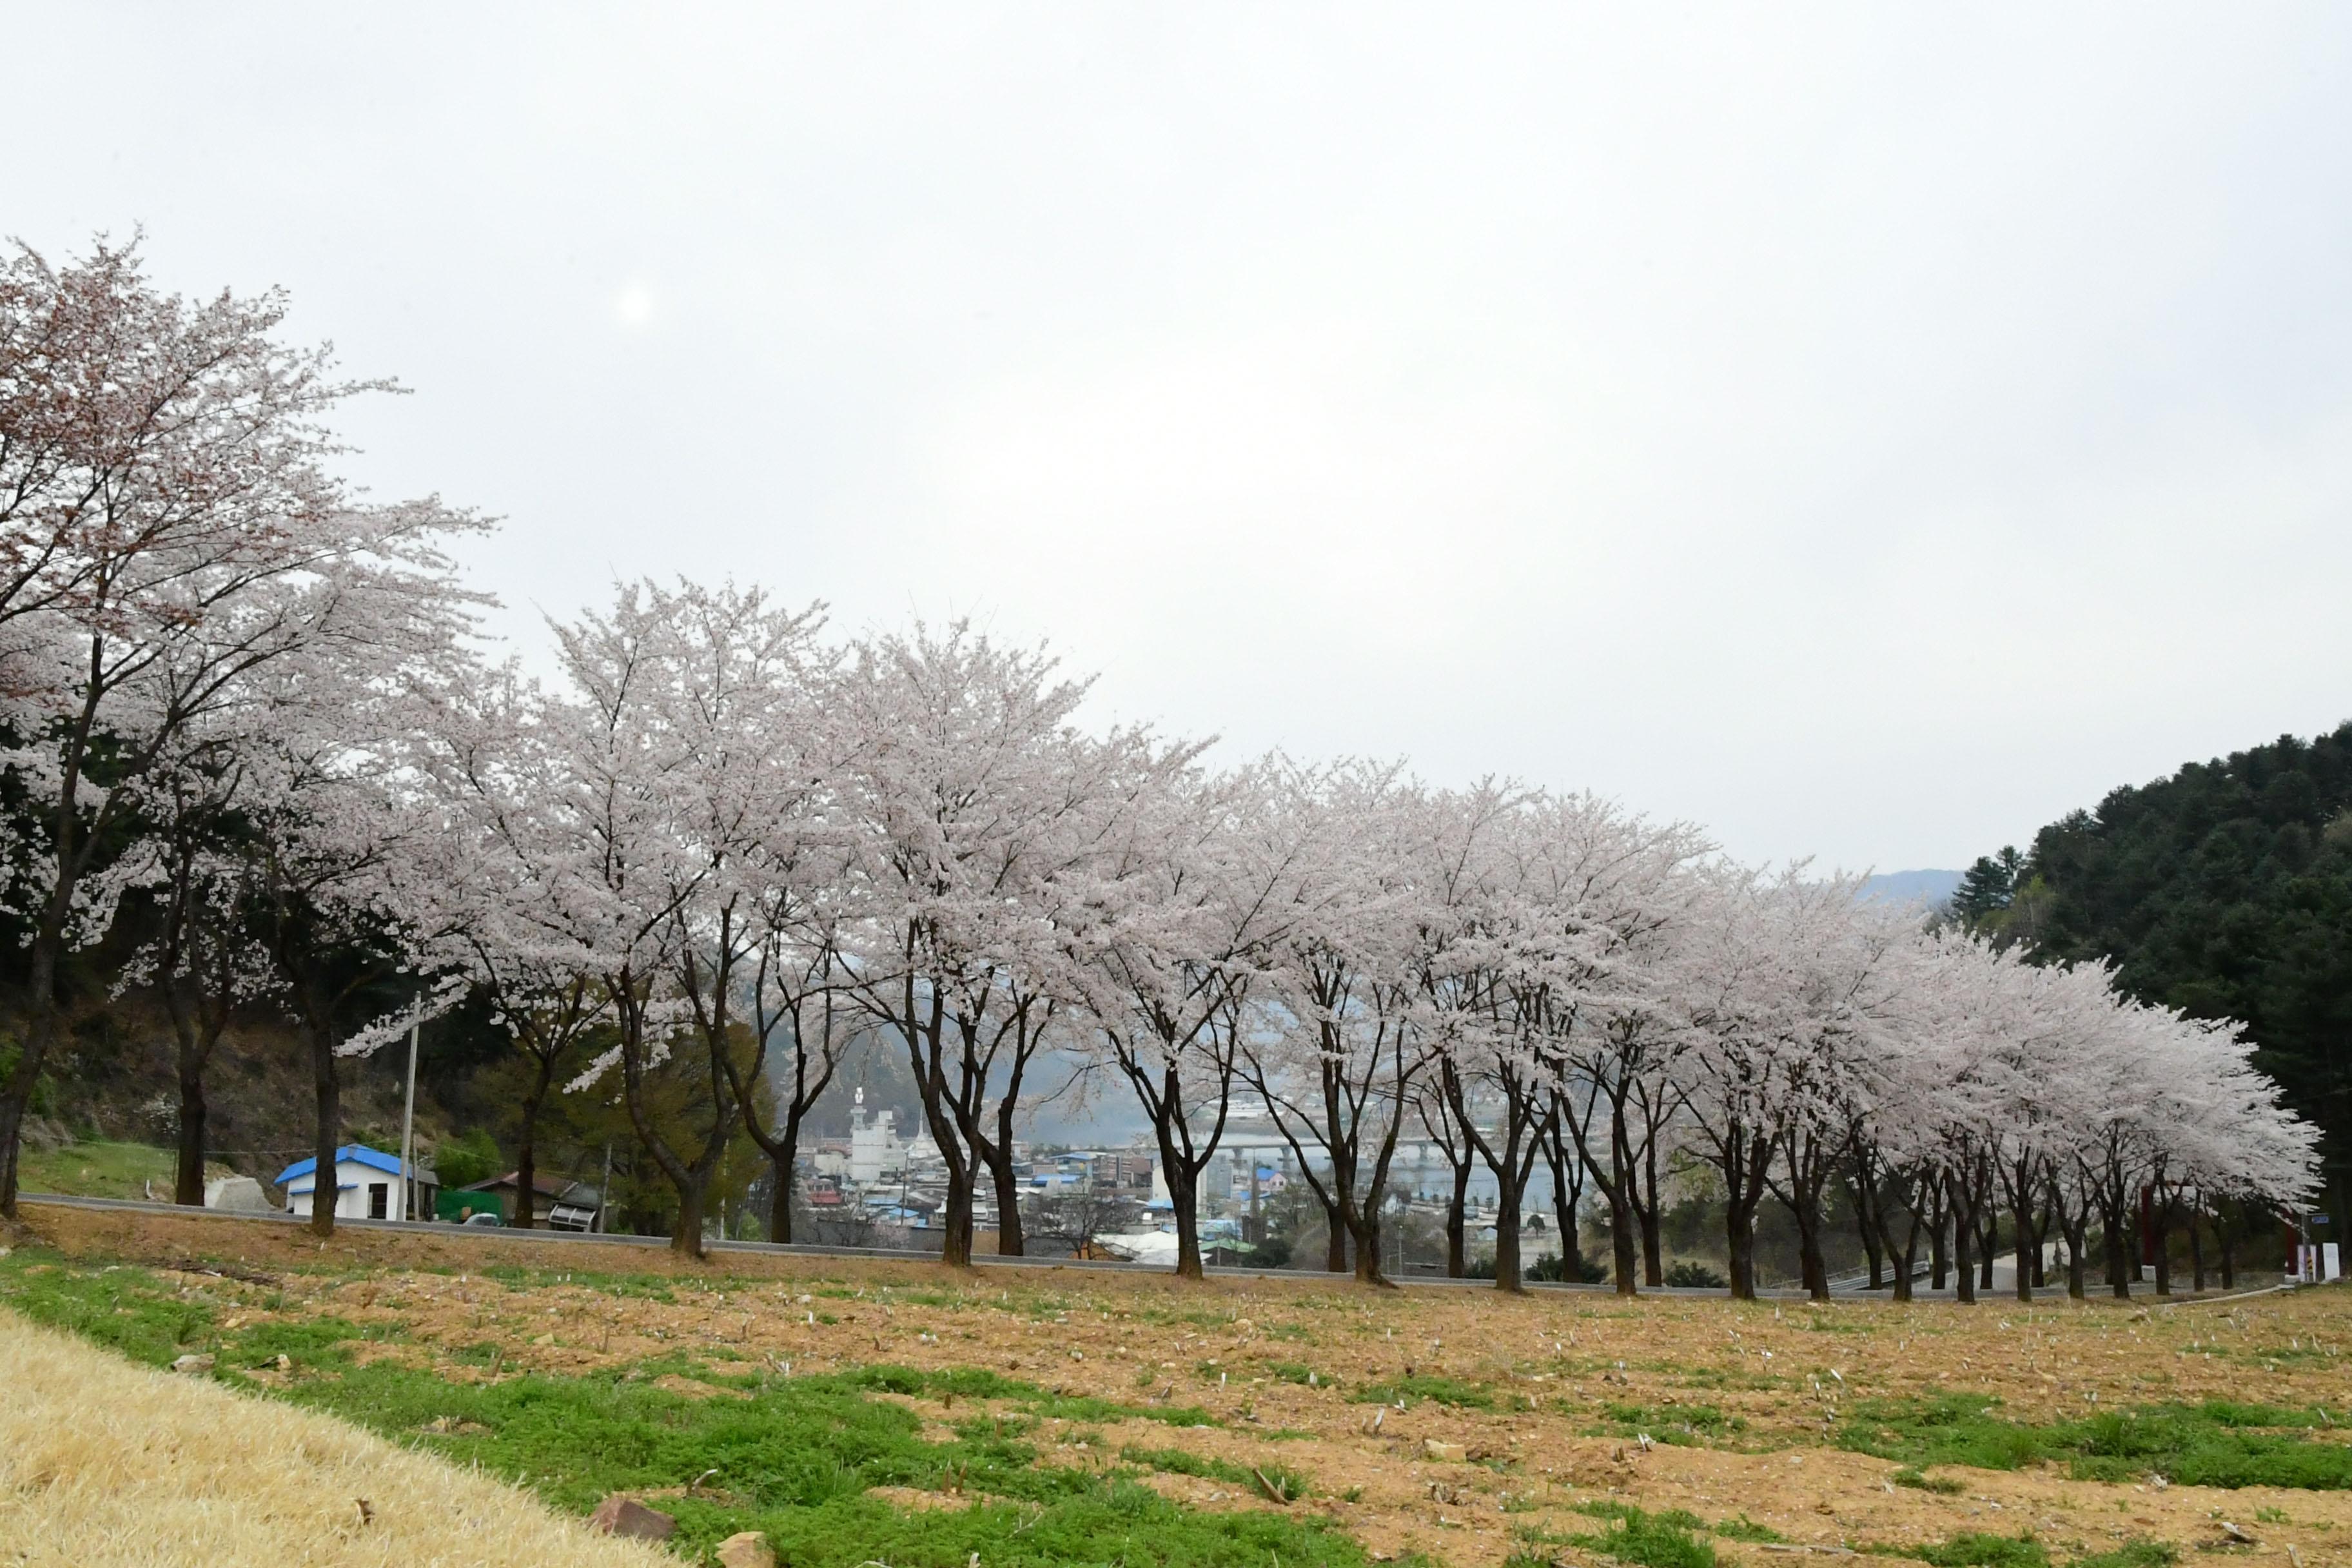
[0,242,478,1215]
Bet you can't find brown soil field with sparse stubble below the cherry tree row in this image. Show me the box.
[26,1206,2352,1568]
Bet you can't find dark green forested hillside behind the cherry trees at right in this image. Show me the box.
[1954,721,2352,1239]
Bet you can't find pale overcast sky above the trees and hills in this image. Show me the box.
[0,5,2352,870]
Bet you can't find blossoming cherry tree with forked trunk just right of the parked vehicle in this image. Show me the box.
[527,583,830,1255]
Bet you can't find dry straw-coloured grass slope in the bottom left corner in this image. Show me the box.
[0,1312,675,1568]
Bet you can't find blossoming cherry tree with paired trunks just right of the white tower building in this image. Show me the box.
[835,623,1190,1265]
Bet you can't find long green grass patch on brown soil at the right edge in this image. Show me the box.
[1837,1394,2352,1491]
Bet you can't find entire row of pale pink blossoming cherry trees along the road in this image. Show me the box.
[0,232,2312,1293]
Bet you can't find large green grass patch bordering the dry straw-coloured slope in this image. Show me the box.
[0,1253,1364,1568]
